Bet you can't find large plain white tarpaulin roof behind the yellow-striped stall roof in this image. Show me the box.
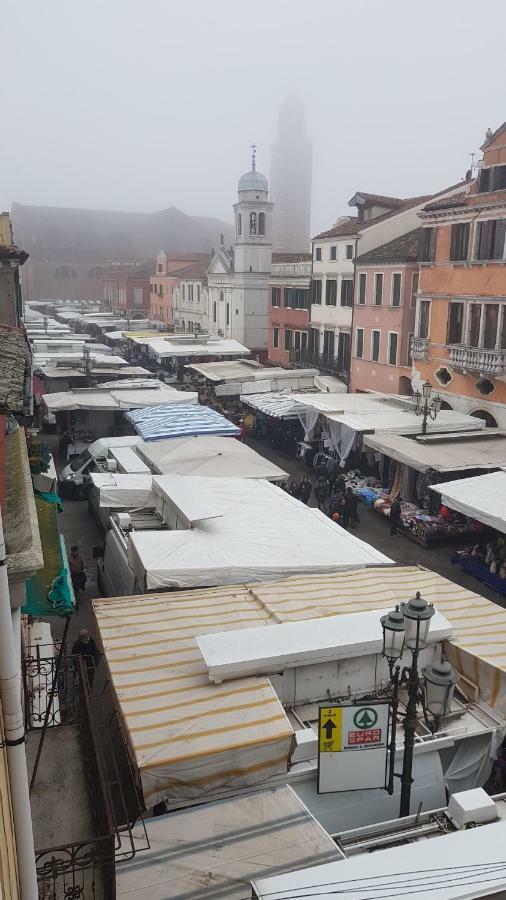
[129,476,391,591]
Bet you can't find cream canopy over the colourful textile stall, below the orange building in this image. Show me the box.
[364,429,506,472]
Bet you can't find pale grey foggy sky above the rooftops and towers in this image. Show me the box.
[0,0,506,234]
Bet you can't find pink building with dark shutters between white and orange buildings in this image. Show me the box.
[350,229,420,394]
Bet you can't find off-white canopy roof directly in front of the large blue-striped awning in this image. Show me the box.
[136,435,288,481]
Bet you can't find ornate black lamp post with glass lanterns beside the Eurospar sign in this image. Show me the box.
[381,591,458,817]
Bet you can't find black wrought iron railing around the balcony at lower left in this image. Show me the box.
[23,656,149,900]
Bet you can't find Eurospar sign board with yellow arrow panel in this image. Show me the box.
[318,703,390,794]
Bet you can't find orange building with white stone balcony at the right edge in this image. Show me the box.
[411,122,506,428]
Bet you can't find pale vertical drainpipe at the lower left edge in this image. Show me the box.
[0,513,38,900]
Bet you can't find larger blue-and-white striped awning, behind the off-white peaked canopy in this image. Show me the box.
[126,403,240,441]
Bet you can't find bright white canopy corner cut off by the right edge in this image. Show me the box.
[431,472,506,534]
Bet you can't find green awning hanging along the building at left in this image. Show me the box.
[22,492,75,618]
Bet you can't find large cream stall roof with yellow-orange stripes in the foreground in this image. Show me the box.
[93,566,506,805]
